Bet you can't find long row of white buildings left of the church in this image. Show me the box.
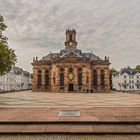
[0,66,33,92]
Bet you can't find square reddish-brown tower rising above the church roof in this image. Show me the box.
[65,29,77,49]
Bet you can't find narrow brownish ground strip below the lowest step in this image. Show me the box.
[0,135,140,140]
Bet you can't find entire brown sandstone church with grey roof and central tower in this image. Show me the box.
[32,29,110,93]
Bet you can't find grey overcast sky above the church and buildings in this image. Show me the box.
[0,0,140,71]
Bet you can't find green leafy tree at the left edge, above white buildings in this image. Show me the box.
[0,15,16,76]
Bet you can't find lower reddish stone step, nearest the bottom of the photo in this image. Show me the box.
[0,123,140,134]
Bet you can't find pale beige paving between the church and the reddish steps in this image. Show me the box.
[0,91,140,108]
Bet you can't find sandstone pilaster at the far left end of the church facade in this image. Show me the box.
[32,68,38,92]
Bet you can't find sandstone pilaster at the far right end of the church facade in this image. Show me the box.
[104,67,110,93]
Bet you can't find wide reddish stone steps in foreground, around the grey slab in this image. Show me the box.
[0,108,140,135]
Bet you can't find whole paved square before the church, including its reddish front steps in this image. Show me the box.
[0,91,140,134]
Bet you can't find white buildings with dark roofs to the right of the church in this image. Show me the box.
[112,67,140,92]
